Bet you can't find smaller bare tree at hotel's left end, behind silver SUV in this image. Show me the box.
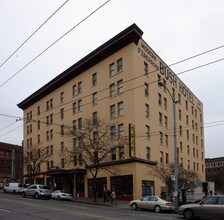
[23,144,49,183]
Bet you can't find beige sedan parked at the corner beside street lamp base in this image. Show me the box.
[129,196,175,212]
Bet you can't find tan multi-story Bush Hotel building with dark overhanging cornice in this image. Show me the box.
[18,24,205,199]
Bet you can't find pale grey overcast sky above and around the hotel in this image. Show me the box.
[0,0,224,158]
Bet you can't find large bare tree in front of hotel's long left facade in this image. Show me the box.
[63,118,127,201]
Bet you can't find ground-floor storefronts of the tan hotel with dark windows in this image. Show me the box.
[23,159,162,201]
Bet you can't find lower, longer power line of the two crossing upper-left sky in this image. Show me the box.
[0,0,110,87]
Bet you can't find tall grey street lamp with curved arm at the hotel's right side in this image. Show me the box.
[158,81,178,208]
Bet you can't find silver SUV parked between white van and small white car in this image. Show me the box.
[22,184,51,199]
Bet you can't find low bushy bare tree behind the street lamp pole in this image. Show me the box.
[150,163,200,196]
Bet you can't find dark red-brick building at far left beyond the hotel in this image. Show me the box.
[0,142,23,183]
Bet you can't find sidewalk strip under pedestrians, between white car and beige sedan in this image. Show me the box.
[72,197,130,209]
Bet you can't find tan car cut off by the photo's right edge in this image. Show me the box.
[178,195,224,220]
